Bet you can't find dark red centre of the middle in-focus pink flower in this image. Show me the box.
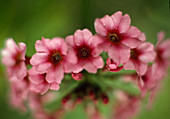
[76,45,91,58]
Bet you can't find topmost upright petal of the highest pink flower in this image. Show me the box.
[111,11,122,29]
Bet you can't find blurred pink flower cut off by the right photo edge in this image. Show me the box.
[153,32,170,80]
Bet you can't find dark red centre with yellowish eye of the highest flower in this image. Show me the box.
[107,30,122,44]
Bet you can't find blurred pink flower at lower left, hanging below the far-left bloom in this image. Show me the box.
[9,77,29,111]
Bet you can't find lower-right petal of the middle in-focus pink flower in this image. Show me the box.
[91,56,104,68]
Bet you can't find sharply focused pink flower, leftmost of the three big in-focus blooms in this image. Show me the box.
[30,38,76,84]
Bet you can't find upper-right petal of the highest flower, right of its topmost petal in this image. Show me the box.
[118,14,131,33]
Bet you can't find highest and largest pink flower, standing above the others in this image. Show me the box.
[95,11,145,64]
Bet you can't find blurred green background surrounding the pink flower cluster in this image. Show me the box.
[0,0,170,119]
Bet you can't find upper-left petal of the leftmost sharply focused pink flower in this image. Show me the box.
[35,40,50,53]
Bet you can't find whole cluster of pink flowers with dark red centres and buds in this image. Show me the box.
[2,11,170,119]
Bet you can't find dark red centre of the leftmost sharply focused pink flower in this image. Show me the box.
[50,52,63,65]
